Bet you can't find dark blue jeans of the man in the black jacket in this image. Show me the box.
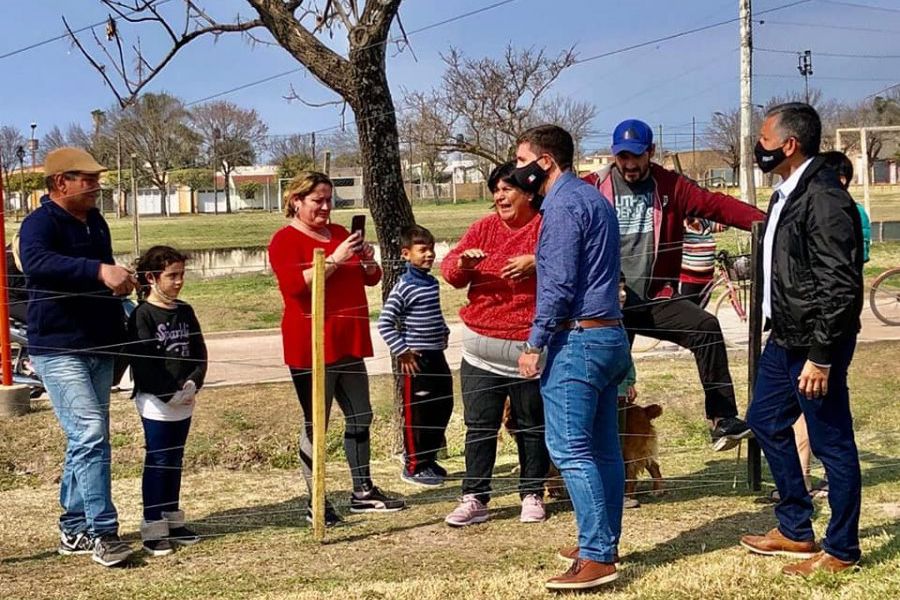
[747,337,862,561]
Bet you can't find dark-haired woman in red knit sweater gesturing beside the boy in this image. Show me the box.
[441,163,550,527]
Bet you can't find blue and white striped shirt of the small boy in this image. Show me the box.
[378,265,450,356]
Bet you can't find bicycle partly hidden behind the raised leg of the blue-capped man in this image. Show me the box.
[632,250,752,352]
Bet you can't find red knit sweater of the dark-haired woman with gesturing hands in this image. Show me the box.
[441,214,541,341]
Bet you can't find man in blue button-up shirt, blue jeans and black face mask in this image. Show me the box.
[513,125,631,589]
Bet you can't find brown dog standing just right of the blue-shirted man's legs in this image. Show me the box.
[619,404,663,497]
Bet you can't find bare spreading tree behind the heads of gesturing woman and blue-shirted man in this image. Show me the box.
[405,45,596,165]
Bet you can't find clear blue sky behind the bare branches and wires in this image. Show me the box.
[0,0,900,154]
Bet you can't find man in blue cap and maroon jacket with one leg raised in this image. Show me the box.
[585,119,765,451]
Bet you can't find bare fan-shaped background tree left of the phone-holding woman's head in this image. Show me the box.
[190,100,269,213]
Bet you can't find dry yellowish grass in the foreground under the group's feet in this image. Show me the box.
[0,343,900,600]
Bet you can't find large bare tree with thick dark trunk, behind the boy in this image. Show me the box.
[70,0,413,296]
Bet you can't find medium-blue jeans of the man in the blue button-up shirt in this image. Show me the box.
[541,327,631,563]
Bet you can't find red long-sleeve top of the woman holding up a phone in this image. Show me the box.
[269,224,381,369]
